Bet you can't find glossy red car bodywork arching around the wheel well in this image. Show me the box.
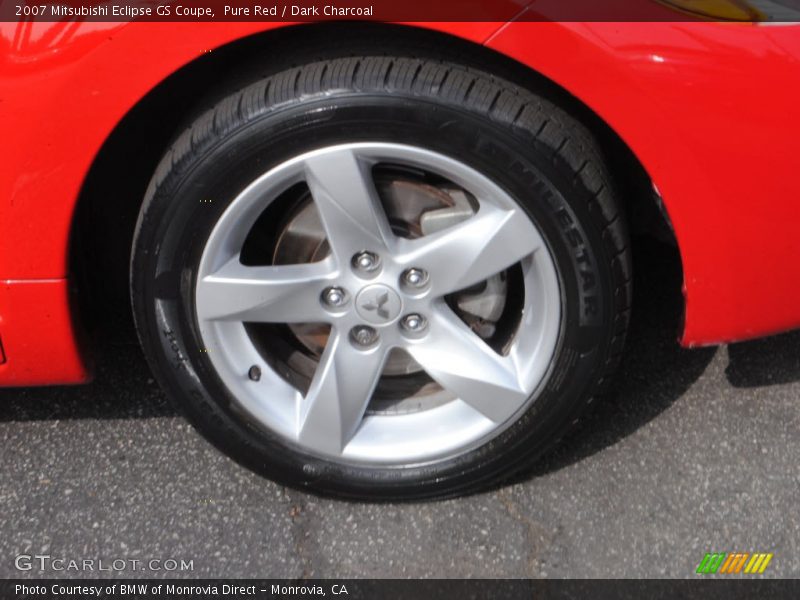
[0,15,800,385]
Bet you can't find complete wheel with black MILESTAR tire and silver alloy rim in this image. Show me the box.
[131,56,631,499]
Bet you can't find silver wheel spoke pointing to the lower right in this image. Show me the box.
[407,306,528,423]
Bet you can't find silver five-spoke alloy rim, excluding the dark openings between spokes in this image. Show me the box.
[195,143,561,466]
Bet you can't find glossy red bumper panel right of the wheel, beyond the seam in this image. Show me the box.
[489,23,800,345]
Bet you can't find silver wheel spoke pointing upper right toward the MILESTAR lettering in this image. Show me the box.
[400,203,542,296]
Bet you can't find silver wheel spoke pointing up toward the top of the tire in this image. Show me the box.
[305,149,393,261]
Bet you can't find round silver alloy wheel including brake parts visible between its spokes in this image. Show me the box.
[195,142,561,466]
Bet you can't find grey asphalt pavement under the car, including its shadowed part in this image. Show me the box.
[0,241,800,578]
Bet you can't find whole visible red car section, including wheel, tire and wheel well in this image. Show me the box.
[0,0,800,498]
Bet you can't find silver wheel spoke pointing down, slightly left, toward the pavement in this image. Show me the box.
[298,331,386,454]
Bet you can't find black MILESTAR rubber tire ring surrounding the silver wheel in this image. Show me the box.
[131,56,631,499]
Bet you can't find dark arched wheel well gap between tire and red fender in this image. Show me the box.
[70,23,670,341]
